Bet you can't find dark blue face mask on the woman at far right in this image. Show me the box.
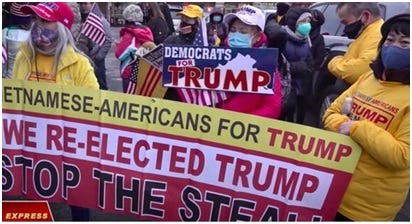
[381,45,410,69]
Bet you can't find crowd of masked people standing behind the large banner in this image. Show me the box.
[3,2,410,221]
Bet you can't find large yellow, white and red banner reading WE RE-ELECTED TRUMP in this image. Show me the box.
[2,80,361,221]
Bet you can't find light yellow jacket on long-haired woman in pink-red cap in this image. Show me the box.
[13,44,99,89]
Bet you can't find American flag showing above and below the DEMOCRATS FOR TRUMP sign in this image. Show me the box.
[177,18,227,107]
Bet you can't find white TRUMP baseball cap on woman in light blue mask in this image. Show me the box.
[223,5,265,30]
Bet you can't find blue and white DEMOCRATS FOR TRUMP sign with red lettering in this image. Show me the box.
[163,45,278,94]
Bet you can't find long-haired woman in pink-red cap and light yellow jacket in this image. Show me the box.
[13,2,99,221]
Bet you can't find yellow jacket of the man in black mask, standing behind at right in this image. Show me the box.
[328,19,384,84]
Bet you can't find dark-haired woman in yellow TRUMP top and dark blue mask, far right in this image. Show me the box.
[324,14,410,221]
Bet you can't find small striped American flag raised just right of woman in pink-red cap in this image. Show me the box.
[80,3,106,46]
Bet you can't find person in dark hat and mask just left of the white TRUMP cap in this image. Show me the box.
[206,8,228,46]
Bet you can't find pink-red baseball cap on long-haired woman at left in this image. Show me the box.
[21,2,74,29]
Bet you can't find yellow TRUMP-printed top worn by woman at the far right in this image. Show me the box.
[323,72,410,221]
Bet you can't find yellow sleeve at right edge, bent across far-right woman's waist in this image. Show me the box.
[350,111,410,170]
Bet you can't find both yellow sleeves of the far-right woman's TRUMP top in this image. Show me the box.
[323,73,410,170]
